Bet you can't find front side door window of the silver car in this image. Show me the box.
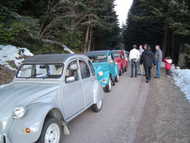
[65,61,79,83]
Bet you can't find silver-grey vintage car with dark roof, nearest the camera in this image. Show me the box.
[0,54,104,143]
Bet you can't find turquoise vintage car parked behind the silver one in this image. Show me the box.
[86,50,119,92]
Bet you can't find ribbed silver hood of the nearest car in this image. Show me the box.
[0,83,59,117]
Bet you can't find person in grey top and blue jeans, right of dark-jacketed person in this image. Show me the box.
[155,45,162,78]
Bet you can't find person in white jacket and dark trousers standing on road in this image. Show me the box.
[129,45,140,77]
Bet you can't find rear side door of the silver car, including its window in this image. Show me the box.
[79,59,96,106]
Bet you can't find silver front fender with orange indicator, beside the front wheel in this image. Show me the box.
[9,103,55,143]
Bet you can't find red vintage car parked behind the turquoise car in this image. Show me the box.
[112,50,128,75]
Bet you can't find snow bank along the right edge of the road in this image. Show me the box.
[173,69,190,101]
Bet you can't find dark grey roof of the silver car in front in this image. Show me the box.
[23,54,82,64]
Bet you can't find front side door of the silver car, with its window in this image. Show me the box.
[63,60,84,120]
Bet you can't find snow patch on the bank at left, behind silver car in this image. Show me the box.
[0,45,33,70]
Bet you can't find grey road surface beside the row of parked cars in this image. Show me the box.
[63,72,190,143]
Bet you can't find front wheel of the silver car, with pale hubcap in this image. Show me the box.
[37,118,62,143]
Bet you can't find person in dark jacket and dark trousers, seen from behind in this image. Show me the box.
[141,46,154,83]
